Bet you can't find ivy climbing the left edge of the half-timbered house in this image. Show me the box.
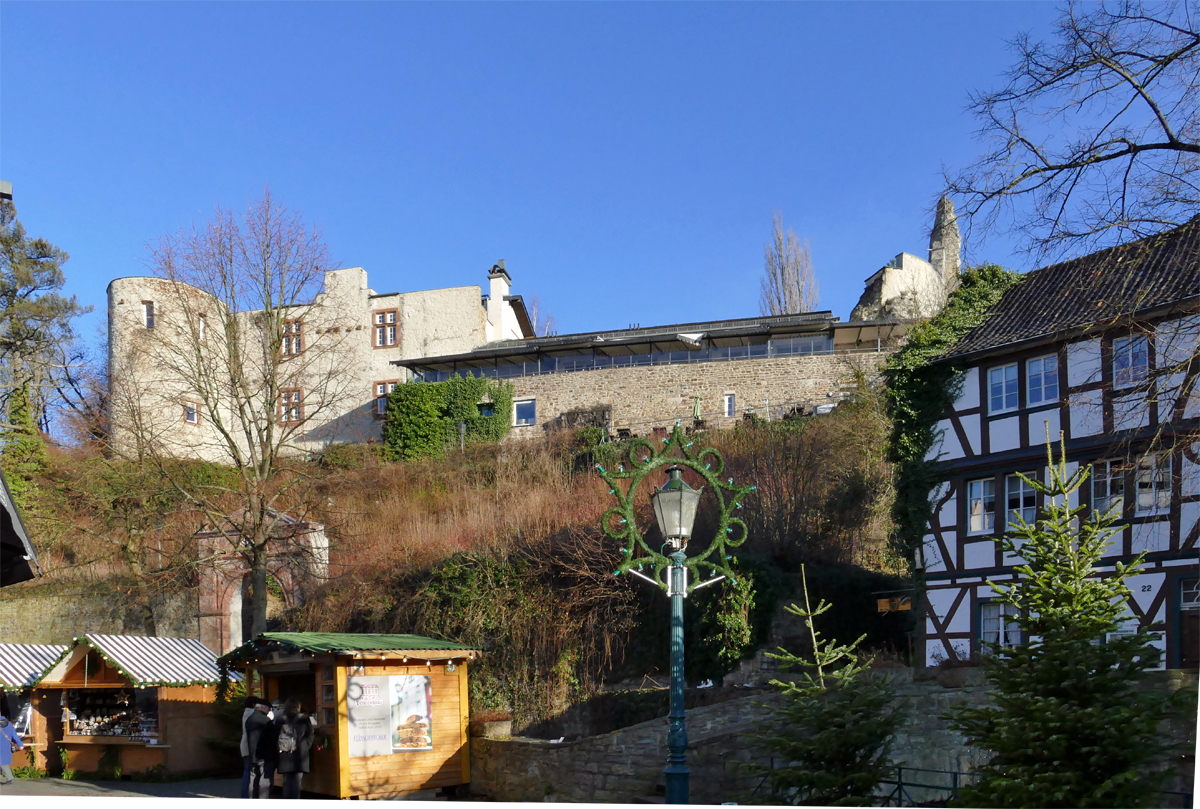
[883,264,1025,558]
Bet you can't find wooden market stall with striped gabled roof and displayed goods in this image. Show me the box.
[30,635,226,774]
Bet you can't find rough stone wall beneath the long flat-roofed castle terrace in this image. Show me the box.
[501,350,890,437]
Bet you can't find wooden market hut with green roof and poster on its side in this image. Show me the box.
[221,633,479,798]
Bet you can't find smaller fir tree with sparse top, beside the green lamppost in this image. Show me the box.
[762,565,900,807]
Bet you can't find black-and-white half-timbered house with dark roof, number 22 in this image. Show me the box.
[918,220,1200,667]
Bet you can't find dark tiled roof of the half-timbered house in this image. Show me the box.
[942,218,1200,360]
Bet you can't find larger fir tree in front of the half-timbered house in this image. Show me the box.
[948,441,1187,807]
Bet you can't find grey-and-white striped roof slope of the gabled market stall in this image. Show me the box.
[78,635,229,685]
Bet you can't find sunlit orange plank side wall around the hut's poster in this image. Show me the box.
[349,665,470,798]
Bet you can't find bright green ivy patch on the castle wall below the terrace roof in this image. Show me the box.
[383,377,512,461]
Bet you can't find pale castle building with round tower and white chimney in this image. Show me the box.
[108,262,533,462]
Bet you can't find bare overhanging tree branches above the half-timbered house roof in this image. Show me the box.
[947,0,1200,258]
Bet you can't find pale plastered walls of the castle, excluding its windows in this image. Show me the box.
[108,268,511,462]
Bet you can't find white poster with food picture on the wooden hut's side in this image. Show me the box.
[346,675,433,757]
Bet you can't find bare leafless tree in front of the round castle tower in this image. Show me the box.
[109,192,352,634]
